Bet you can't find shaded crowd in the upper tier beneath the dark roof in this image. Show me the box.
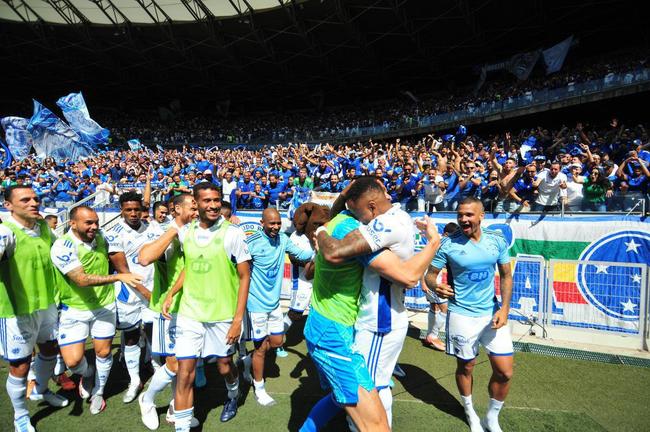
[101,51,647,146]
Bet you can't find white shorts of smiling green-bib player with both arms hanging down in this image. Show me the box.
[176,315,241,360]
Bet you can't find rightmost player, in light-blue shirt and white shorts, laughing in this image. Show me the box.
[425,197,513,432]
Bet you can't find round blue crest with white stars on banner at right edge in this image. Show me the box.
[576,230,650,321]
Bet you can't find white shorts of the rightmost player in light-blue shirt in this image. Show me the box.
[446,311,514,360]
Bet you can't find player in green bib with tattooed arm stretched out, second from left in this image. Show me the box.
[50,206,142,414]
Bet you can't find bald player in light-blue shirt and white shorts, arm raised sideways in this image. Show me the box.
[244,208,314,406]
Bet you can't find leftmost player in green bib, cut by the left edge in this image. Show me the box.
[0,186,68,432]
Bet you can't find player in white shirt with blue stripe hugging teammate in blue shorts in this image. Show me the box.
[317,177,440,425]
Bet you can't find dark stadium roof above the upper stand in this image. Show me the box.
[0,0,636,110]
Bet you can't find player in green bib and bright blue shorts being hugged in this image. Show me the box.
[301,212,389,431]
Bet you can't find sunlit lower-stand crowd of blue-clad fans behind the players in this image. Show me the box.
[0,119,650,213]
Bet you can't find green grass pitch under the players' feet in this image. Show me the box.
[0,326,650,432]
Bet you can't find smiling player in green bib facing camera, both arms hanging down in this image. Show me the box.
[163,182,251,432]
